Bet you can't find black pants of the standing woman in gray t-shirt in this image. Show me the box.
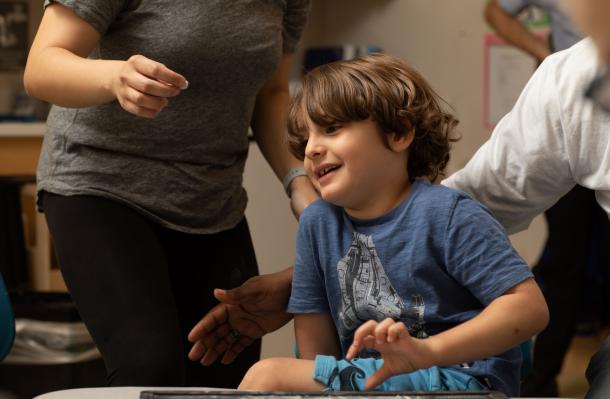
[42,193,260,388]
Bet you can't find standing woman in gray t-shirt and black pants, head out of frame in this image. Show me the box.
[24,0,315,387]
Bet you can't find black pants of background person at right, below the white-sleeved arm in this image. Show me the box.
[521,186,610,397]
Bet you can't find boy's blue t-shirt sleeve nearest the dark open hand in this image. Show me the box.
[288,205,330,313]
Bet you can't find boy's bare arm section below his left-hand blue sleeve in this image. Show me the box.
[294,313,341,360]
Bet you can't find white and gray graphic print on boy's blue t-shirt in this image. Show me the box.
[337,232,427,348]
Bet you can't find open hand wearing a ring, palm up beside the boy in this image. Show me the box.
[188,268,292,366]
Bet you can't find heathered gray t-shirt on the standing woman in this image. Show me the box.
[38,0,309,233]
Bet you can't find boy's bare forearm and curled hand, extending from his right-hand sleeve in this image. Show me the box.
[347,279,549,389]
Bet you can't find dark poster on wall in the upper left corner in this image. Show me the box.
[0,1,29,72]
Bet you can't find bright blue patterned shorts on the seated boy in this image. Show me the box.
[313,355,489,392]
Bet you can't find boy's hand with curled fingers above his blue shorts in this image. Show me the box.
[346,318,434,390]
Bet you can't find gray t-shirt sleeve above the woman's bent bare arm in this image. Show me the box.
[44,0,132,35]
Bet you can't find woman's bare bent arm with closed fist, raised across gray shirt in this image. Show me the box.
[24,3,188,117]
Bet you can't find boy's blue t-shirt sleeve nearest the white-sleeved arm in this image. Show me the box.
[445,197,532,305]
